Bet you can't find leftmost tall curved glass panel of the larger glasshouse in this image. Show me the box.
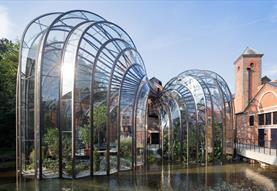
[17,13,61,175]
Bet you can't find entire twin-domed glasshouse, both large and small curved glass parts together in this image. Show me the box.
[16,10,234,179]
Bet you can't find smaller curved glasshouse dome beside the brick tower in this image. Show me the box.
[157,70,233,163]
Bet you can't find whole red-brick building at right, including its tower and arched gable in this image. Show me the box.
[234,47,277,148]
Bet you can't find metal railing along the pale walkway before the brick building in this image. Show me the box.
[236,139,277,156]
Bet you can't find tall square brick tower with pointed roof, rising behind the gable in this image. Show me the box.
[234,47,263,113]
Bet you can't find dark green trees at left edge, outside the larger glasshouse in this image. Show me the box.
[0,39,19,148]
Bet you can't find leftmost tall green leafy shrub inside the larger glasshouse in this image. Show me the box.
[44,128,59,158]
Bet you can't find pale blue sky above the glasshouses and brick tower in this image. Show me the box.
[0,0,277,93]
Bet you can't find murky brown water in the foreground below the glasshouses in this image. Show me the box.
[0,163,277,191]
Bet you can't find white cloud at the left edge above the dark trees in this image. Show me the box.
[0,6,13,38]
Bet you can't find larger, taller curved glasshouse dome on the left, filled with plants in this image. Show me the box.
[17,10,149,178]
